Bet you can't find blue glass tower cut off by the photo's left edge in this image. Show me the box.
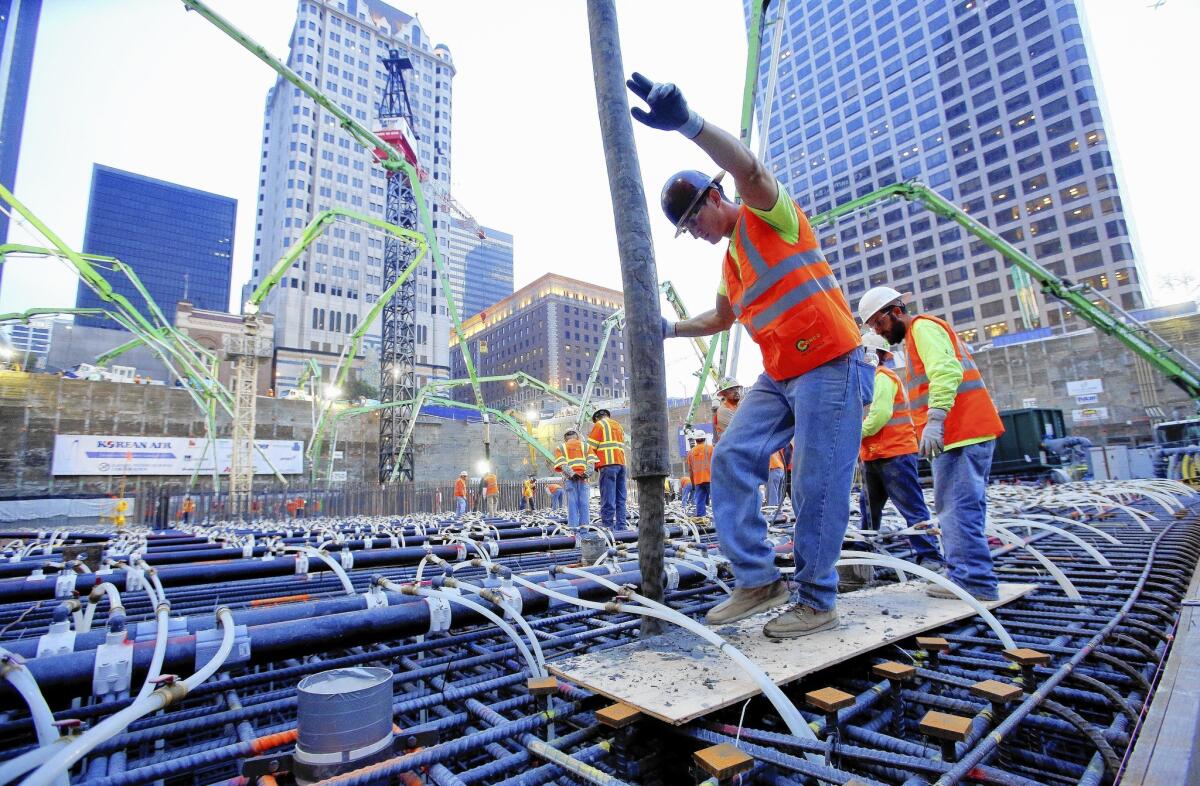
[0,0,42,288]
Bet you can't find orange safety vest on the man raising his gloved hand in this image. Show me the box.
[724,200,863,380]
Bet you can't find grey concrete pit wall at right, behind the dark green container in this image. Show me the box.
[974,314,1200,444]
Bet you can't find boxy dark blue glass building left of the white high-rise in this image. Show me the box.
[76,164,238,328]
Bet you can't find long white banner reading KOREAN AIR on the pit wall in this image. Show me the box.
[52,434,304,475]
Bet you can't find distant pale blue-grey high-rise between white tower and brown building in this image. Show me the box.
[446,218,512,318]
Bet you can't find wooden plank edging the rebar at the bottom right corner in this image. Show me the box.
[1121,544,1200,786]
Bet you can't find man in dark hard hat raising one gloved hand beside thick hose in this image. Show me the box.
[628,73,871,638]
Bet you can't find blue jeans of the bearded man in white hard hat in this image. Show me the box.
[934,439,998,598]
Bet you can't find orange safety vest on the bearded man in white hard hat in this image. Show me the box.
[904,314,1004,445]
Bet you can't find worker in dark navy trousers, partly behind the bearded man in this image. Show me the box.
[858,331,943,570]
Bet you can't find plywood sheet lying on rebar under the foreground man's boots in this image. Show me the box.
[547,582,1034,724]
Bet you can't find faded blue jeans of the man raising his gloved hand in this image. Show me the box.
[713,348,874,611]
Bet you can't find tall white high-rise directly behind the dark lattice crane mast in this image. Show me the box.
[248,0,455,391]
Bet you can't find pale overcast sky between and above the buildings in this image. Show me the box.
[0,0,1200,395]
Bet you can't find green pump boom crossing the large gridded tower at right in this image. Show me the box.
[810,181,1200,403]
